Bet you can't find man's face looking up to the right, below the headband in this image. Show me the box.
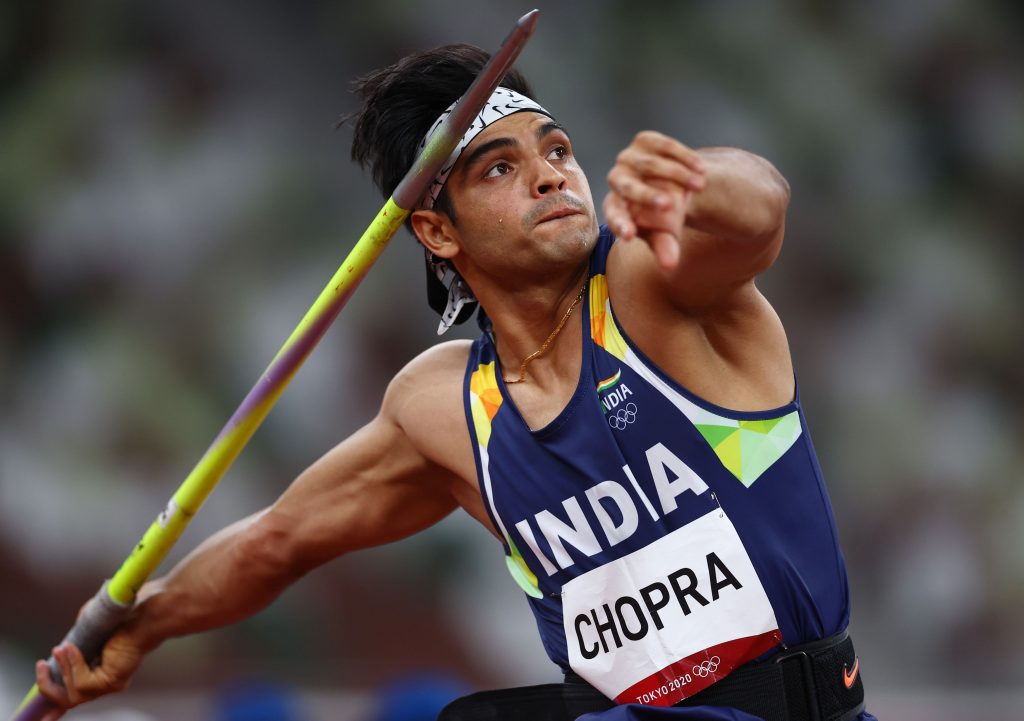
[432,112,598,279]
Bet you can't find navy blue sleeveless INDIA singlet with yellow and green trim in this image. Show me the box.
[465,227,864,706]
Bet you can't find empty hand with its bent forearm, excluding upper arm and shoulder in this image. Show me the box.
[604,131,790,311]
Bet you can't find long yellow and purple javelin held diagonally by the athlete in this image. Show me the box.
[10,10,540,721]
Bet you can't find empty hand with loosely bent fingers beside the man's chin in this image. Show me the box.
[604,130,706,269]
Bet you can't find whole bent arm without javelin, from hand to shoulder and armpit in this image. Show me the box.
[604,131,795,411]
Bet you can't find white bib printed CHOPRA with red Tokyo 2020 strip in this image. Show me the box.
[562,509,782,706]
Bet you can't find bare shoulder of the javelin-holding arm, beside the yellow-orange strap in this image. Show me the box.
[381,340,475,478]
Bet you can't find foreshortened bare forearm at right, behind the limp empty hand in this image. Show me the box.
[686,147,790,242]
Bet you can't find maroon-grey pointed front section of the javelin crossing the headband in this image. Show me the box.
[391,10,541,210]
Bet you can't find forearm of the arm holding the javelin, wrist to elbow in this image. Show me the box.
[123,512,300,652]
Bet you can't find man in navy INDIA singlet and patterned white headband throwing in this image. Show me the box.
[37,45,871,721]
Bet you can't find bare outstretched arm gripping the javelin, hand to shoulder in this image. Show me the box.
[36,348,464,708]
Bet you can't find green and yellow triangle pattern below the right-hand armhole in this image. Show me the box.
[694,411,803,487]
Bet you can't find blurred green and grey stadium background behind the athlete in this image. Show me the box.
[0,0,1024,721]
